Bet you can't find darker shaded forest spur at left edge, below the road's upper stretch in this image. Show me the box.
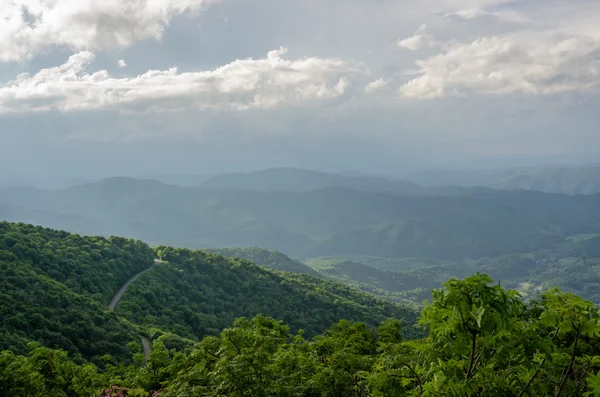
[0,260,136,361]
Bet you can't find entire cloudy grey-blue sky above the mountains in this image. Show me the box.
[0,0,600,183]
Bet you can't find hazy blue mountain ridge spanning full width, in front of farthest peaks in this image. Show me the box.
[0,178,600,260]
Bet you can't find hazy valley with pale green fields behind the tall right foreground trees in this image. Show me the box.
[307,234,600,303]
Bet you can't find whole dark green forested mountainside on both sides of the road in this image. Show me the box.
[0,222,418,364]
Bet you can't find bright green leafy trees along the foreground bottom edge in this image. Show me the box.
[0,274,600,397]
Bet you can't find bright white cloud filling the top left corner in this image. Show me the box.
[0,0,219,62]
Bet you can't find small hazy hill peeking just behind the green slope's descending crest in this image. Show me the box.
[204,247,319,277]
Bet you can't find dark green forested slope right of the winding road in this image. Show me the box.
[116,247,416,338]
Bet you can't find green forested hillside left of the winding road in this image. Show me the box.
[0,222,154,360]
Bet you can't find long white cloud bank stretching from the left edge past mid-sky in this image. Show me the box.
[0,48,361,113]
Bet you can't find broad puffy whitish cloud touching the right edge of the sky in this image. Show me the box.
[400,31,600,99]
